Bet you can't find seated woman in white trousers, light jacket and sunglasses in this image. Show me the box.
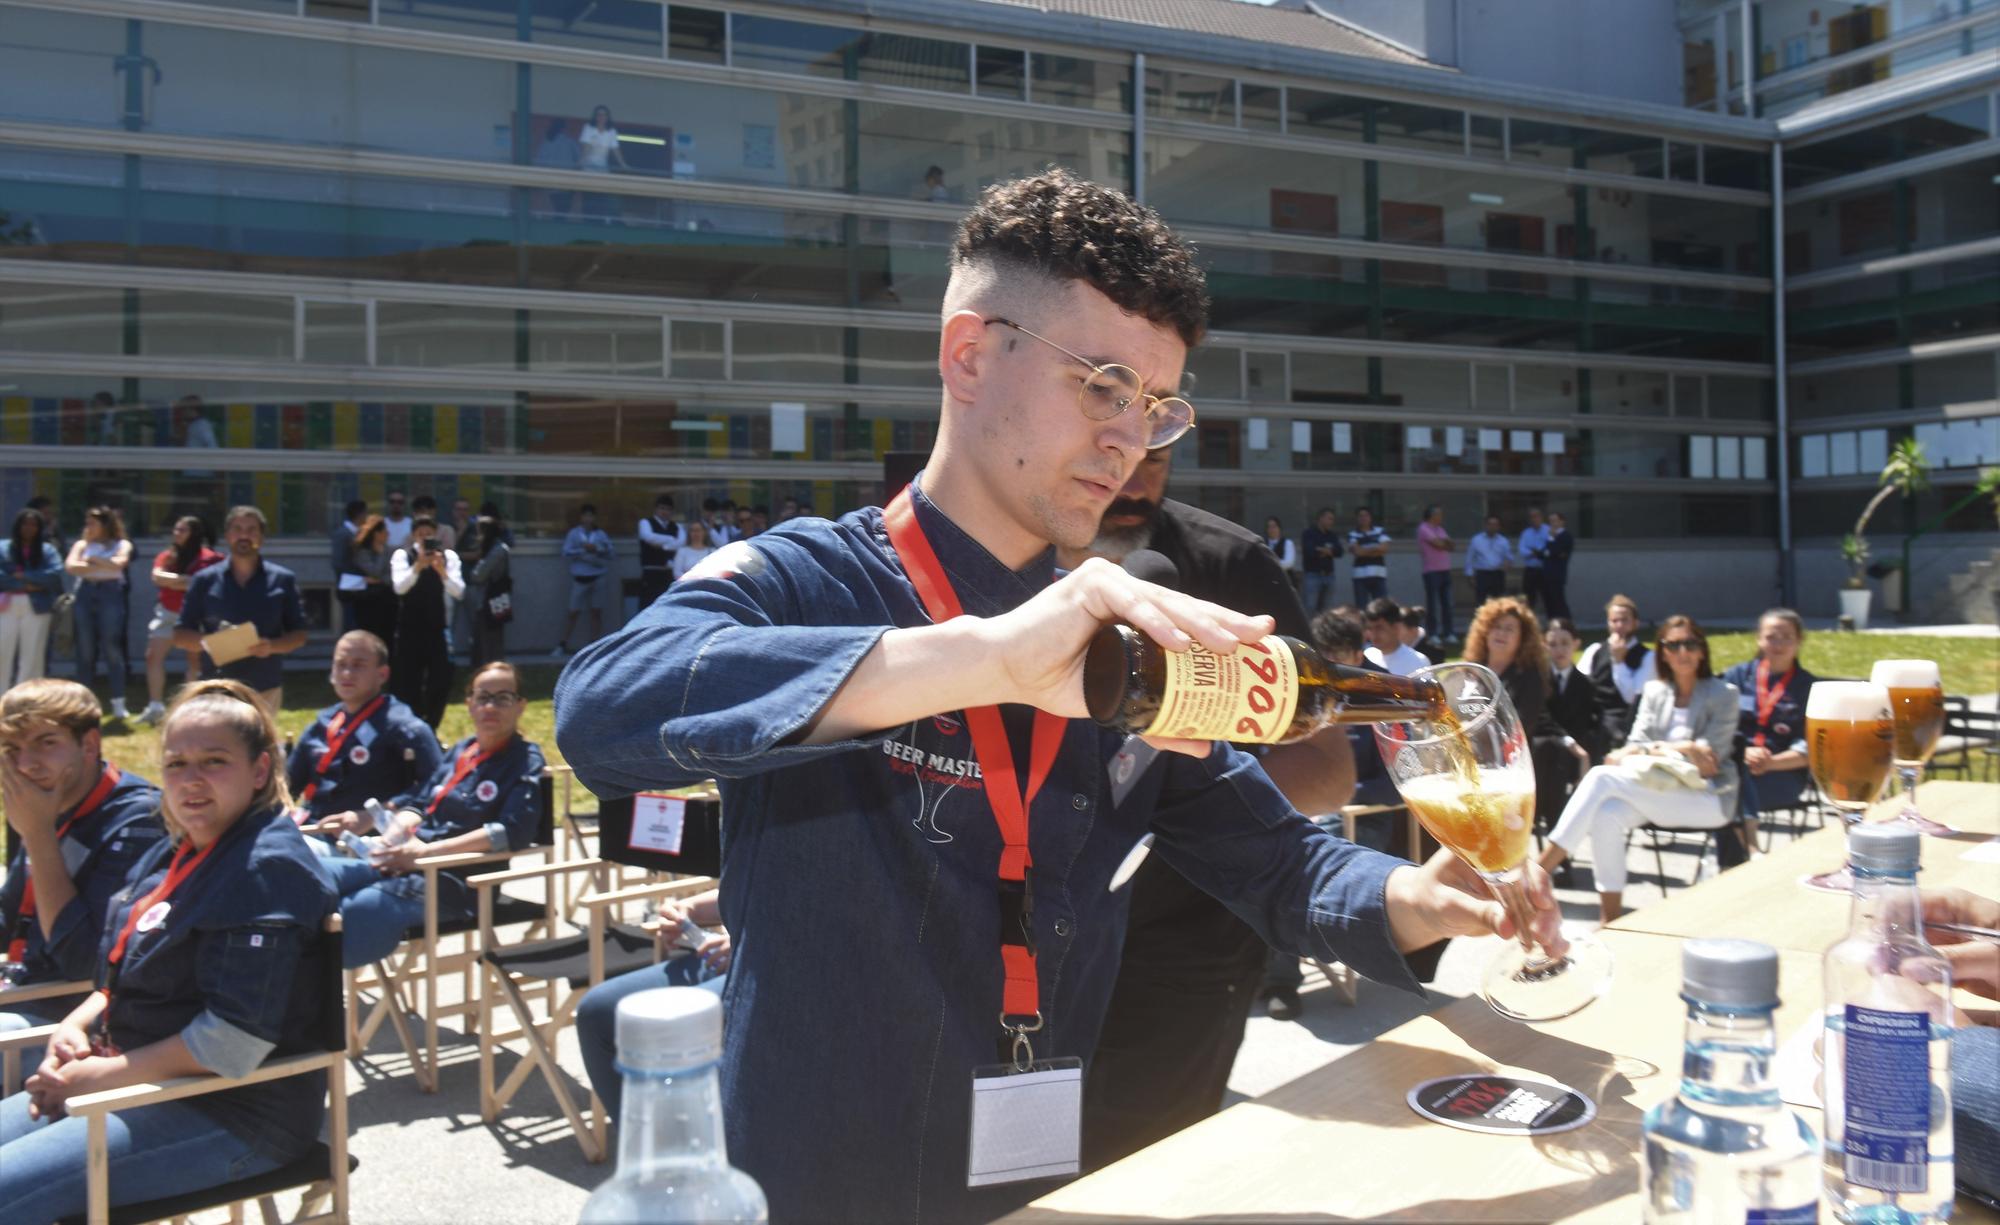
[1542,617,1736,923]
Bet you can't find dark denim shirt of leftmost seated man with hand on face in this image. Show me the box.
[0,771,166,988]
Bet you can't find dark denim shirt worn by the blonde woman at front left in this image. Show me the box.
[98,807,336,1163]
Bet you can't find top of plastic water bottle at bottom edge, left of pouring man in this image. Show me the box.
[580,987,770,1225]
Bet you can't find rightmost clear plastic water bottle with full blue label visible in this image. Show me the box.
[1822,821,1952,1225]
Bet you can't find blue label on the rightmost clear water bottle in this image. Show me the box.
[1844,1005,1930,1191]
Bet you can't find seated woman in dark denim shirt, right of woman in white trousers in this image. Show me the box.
[1722,608,1814,847]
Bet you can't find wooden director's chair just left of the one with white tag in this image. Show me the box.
[346,773,558,1093]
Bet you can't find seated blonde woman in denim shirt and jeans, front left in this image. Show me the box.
[0,681,338,1223]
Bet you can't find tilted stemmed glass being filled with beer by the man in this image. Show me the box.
[1376,663,1612,1021]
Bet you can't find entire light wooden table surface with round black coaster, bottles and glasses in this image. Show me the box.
[1008,783,2000,1223]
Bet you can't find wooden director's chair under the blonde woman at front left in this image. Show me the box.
[0,915,358,1225]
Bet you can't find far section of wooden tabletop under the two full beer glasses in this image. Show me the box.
[1612,783,2000,953]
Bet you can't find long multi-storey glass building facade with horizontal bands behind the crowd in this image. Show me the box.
[0,0,1800,620]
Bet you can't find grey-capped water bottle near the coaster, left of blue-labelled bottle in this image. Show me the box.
[1640,941,1820,1225]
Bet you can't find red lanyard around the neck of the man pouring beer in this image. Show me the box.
[882,488,1068,1037]
